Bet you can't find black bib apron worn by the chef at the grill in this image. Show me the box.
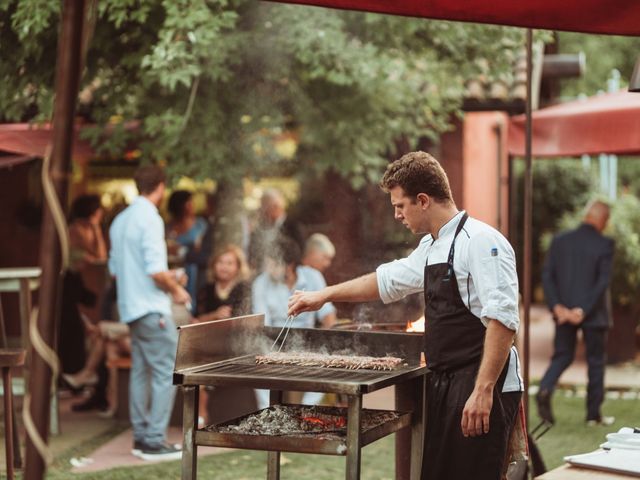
[422,213,521,480]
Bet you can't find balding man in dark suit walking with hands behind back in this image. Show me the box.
[536,201,615,425]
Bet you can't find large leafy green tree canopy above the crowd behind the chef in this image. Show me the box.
[0,0,523,186]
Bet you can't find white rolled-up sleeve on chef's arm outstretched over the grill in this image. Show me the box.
[376,239,431,303]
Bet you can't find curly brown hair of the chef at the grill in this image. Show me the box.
[380,151,453,203]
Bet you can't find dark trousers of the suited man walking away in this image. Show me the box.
[540,323,607,420]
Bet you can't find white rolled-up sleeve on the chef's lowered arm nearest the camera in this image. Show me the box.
[468,231,520,332]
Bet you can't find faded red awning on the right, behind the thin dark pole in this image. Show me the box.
[507,91,640,157]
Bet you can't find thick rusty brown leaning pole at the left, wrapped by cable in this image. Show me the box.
[24,0,85,480]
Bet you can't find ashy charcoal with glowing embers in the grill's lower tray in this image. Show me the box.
[205,405,399,436]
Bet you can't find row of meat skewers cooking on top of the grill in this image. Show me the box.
[256,352,405,370]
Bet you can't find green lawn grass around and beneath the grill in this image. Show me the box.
[42,392,640,480]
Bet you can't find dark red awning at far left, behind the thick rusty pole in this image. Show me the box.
[0,123,95,163]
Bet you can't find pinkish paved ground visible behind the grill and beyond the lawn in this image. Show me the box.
[0,306,640,472]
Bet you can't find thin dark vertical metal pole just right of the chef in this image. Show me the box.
[522,28,533,430]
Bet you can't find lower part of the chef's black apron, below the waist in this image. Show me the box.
[422,365,522,480]
